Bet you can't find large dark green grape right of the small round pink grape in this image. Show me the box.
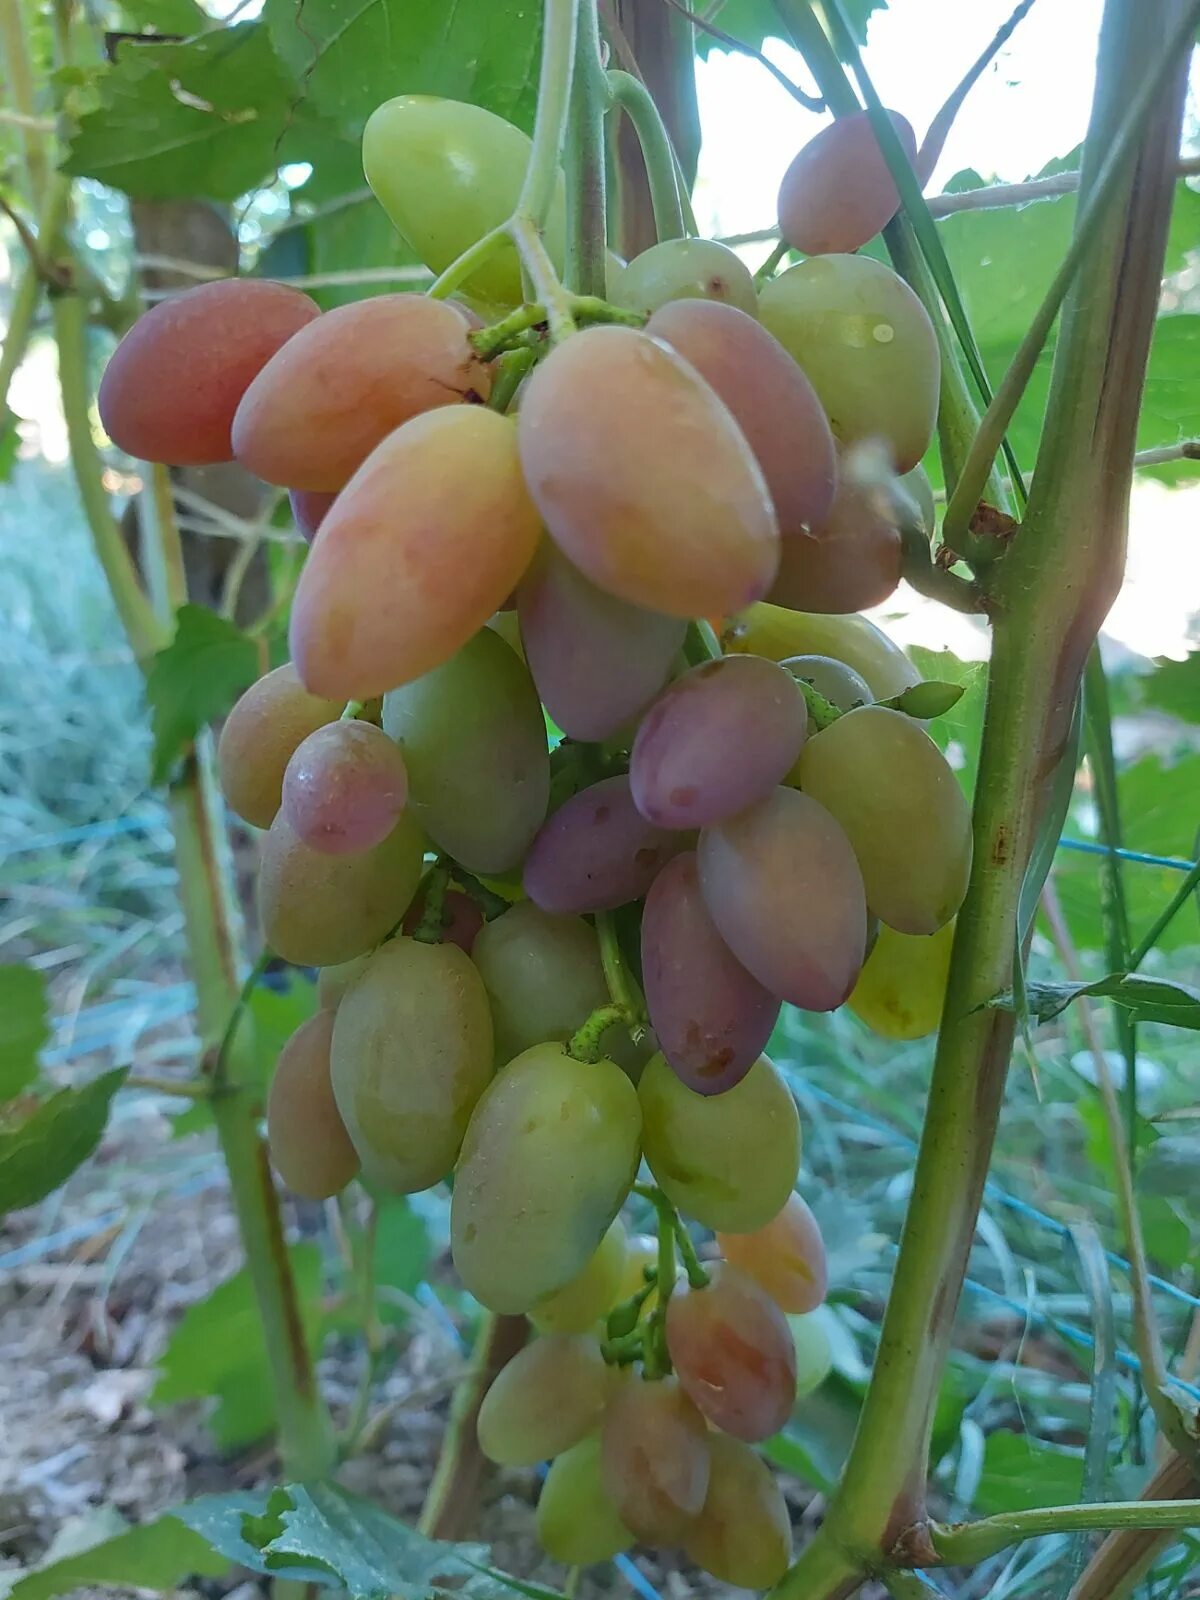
[382,627,550,872]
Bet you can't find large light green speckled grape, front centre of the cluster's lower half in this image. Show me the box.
[450,1045,642,1312]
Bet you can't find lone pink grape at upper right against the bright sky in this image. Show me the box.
[779,110,917,256]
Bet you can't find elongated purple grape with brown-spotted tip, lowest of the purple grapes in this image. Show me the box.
[642,850,779,1094]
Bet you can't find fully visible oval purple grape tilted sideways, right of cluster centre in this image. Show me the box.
[629,656,808,827]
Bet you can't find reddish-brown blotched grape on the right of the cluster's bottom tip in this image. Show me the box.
[667,1262,795,1445]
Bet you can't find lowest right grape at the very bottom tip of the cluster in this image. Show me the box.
[683,1434,792,1589]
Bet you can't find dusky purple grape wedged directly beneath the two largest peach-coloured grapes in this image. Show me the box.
[517,539,688,742]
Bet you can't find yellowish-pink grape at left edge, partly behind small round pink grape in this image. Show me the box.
[216,662,344,827]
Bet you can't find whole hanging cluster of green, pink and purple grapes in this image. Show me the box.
[101,98,971,1587]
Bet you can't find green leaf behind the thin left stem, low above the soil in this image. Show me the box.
[150,1243,322,1450]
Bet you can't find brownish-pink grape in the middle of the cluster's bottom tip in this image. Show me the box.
[600,1378,709,1546]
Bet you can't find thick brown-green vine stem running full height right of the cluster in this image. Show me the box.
[778,0,1190,1600]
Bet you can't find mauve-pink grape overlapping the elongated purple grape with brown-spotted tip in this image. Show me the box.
[698,789,867,1011]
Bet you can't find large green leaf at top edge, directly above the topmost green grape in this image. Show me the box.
[270,0,541,130]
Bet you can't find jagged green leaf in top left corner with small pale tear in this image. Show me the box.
[62,24,299,200]
